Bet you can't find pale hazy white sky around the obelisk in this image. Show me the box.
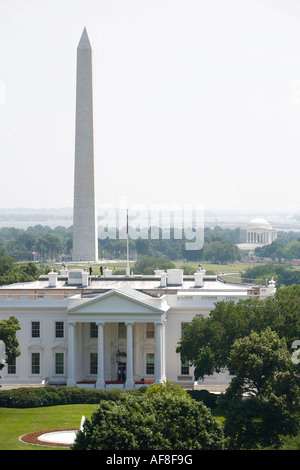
[0,0,300,210]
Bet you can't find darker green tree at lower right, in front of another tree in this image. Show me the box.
[218,328,300,449]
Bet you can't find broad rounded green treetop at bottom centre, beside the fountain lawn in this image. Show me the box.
[73,386,225,450]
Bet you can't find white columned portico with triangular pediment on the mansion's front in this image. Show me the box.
[67,286,169,389]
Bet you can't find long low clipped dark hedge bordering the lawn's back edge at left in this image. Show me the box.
[0,385,122,408]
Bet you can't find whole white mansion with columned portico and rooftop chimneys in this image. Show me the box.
[0,269,275,390]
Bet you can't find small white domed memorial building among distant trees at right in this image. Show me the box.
[239,217,277,249]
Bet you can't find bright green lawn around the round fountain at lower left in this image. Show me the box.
[0,405,97,450]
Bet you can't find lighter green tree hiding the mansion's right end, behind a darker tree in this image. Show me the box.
[177,285,300,380]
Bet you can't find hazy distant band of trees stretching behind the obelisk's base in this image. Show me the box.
[0,224,300,263]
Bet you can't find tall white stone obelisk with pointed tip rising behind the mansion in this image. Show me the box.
[72,28,98,262]
